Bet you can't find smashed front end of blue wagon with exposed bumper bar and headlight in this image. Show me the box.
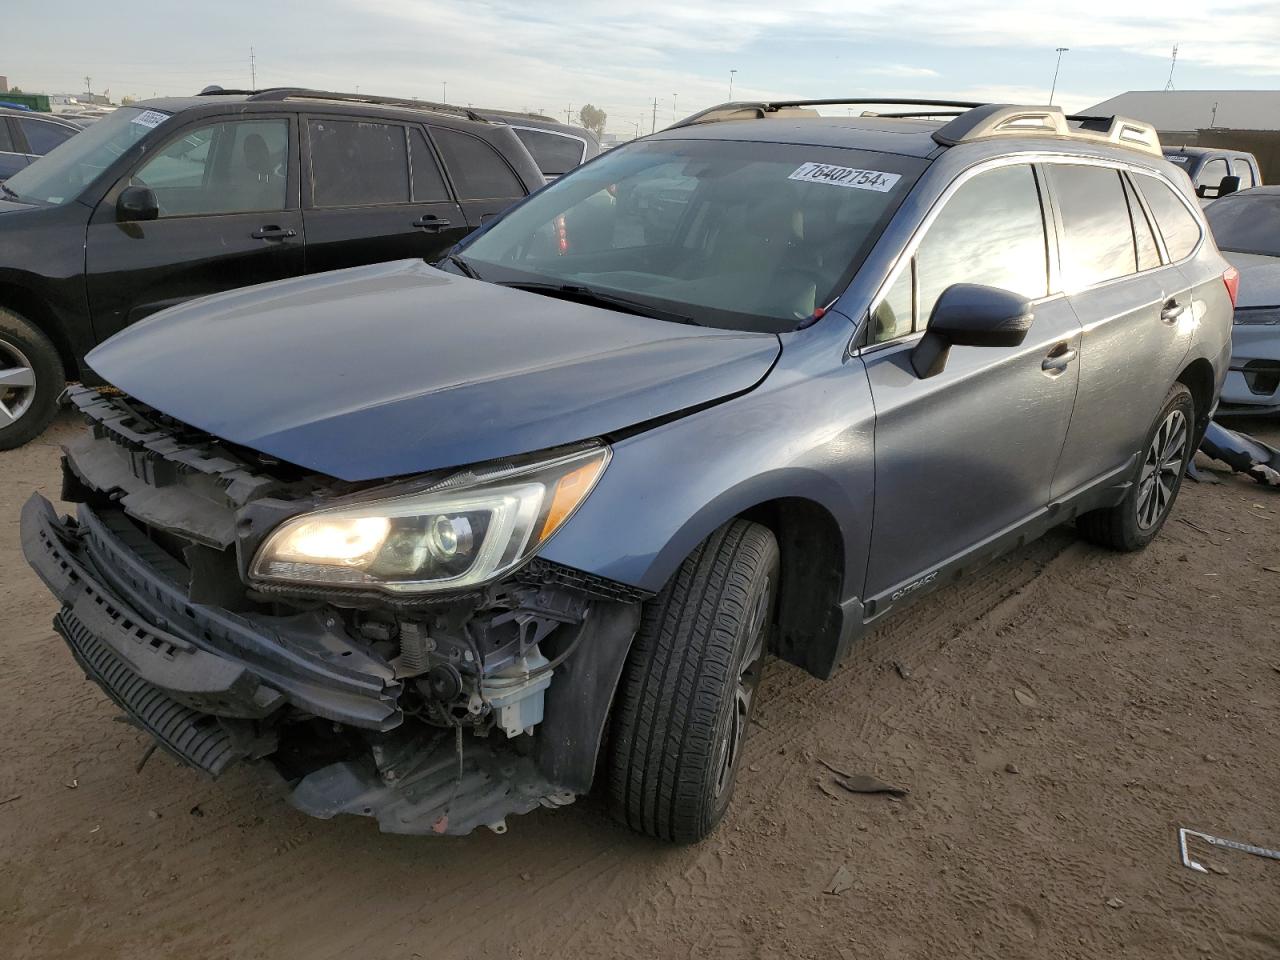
[22,389,646,835]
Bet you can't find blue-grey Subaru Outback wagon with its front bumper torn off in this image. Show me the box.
[22,101,1235,841]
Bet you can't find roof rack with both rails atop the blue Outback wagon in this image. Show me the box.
[668,97,1161,156]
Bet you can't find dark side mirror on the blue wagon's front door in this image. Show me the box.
[911,283,1036,380]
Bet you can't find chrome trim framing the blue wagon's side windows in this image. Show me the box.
[849,152,1204,355]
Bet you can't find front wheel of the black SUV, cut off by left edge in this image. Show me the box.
[0,307,67,451]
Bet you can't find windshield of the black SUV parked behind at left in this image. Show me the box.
[5,106,169,206]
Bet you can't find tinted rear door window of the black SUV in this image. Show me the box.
[307,119,410,207]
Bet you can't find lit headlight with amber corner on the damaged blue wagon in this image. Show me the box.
[250,447,609,594]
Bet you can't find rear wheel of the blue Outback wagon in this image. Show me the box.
[1075,383,1196,552]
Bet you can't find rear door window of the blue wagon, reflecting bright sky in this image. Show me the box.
[1047,164,1138,293]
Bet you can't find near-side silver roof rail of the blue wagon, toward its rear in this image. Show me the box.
[933,104,1161,156]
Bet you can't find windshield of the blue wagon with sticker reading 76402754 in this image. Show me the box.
[462,140,924,333]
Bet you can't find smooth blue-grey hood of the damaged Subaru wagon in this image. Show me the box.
[88,260,781,480]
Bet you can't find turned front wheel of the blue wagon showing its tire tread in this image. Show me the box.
[609,520,778,844]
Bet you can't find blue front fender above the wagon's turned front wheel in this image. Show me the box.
[544,316,874,599]
